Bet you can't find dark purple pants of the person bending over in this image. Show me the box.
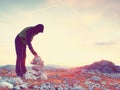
[15,36,26,76]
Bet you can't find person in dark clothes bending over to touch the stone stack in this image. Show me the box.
[15,24,44,77]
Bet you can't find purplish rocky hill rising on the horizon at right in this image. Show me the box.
[80,60,120,74]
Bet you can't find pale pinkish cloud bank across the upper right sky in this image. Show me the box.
[47,0,120,17]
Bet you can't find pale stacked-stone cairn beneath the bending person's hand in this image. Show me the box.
[25,56,47,80]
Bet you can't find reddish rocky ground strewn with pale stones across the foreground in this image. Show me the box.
[0,61,120,90]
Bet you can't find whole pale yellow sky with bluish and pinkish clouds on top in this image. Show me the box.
[0,0,120,67]
